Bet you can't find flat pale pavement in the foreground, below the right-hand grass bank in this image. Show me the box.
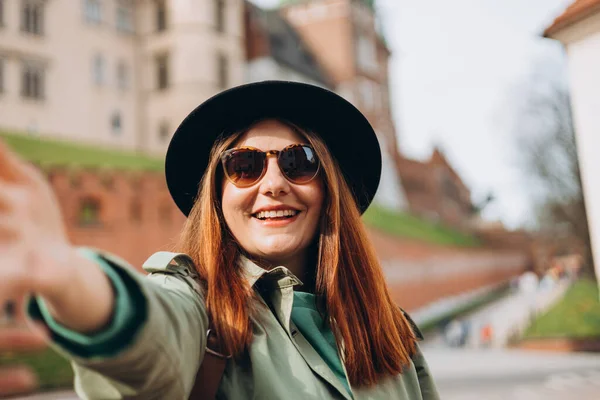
[423,347,600,400]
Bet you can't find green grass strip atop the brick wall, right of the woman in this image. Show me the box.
[363,205,479,247]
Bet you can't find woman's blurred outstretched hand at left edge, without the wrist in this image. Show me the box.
[0,141,73,306]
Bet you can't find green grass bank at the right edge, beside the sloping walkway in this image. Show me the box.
[524,279,600,339]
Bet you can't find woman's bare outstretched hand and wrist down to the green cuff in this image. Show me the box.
[0,140,114,338]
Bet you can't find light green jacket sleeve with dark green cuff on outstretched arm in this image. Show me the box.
[33,250,208,399]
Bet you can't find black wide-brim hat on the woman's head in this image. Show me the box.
[165,81,381,216]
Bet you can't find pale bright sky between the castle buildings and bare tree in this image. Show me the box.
[252,0,573,228]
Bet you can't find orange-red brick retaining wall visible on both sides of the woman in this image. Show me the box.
[46,168,528,310]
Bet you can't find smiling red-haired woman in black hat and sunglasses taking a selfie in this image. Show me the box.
[0,81,438,399]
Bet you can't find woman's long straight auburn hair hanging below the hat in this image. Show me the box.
[178,121,416,386]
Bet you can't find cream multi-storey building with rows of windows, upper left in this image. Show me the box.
[0,0,244,154]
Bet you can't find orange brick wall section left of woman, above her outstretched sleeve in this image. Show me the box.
[45,164,185,270]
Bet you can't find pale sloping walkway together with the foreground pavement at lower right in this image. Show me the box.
[422,276,600,400]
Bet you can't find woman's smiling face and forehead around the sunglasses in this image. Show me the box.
[222,120,323,269]
